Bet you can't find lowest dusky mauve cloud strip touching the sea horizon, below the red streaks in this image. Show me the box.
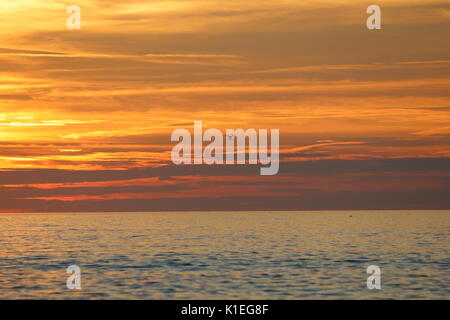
[0,188,450,213]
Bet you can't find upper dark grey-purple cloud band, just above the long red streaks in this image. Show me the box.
[0,157,450,186]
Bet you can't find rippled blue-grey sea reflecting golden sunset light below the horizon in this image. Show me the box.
[0,211,450,299]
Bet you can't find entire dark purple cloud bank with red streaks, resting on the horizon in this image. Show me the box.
[0,158,450,212]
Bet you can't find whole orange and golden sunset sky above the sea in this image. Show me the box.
[0,0,450,212]
